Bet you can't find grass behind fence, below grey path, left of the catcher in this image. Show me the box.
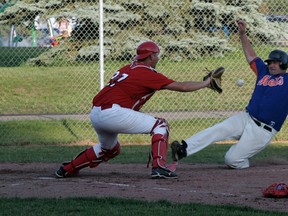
[0,119,96,146]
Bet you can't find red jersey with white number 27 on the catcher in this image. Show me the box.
[93,62,175,111]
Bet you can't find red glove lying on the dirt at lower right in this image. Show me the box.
[262,183,288,198]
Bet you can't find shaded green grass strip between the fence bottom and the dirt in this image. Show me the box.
[0,143,288,164]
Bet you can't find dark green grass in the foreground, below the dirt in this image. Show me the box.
[0,198,286,216]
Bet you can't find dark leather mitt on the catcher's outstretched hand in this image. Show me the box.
[203,67,225,94]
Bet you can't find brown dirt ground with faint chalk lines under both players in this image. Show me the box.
[0,163,288,212]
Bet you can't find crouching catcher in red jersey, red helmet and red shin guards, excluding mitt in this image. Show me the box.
[55,41,210,178]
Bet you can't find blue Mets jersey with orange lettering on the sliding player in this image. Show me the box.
[246,58,288,131]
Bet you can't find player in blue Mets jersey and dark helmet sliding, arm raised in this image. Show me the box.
[171,20,288,169]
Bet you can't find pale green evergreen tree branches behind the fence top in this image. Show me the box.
[0,0,288,65]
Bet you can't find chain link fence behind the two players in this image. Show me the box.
[0,0,288,145]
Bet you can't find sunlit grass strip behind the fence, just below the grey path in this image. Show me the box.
[0,118,224,146]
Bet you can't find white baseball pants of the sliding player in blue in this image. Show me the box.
[184,111,277,169]
